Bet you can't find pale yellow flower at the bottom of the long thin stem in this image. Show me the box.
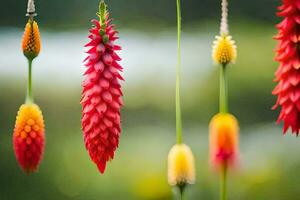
[168,144,196,186]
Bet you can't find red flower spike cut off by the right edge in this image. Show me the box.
[273,0,300,135]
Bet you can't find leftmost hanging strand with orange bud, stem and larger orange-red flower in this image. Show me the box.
[13,0,45,174]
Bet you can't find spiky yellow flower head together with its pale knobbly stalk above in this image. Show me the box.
[212,0,237,65]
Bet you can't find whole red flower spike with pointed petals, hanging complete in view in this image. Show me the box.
[81,1,123,173]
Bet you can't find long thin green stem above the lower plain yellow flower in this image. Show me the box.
[176,0,182,144]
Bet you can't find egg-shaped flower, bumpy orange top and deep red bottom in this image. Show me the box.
[13,104,45,174]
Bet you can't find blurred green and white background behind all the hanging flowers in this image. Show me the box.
[0,0,300,200]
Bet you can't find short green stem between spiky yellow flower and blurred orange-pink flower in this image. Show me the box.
[220,65,228,113]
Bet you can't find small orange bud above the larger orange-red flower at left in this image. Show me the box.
[22,18,41,60]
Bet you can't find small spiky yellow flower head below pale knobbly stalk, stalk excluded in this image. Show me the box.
[212,34,237,65]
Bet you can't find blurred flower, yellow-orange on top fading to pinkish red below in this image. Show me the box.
[209,113,239,167]
